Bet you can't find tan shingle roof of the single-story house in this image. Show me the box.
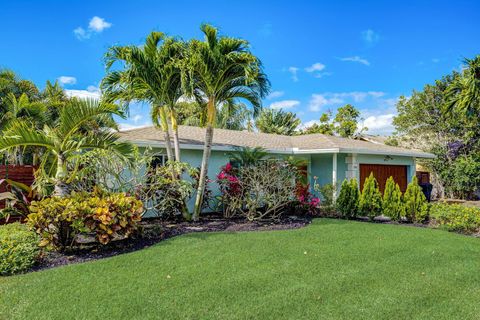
[119,126,433,158]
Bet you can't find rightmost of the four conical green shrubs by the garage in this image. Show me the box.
[403,176,428,222]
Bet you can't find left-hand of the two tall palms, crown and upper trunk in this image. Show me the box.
[101,31,184,161]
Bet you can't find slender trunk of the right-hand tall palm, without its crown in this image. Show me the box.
[192,98,216,221]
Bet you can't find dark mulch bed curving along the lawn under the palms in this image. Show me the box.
[31,216,311,271]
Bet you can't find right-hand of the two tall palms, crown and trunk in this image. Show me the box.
[182,24,269,220]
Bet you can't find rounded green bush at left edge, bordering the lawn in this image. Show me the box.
[0,223,39,275]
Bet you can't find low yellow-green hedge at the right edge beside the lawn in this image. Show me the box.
[430,203,480,233]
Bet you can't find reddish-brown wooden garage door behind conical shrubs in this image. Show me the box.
[360,164,407,193]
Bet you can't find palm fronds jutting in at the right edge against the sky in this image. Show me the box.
[446,55,480,118]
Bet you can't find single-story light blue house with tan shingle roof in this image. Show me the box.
[120,126,434,206]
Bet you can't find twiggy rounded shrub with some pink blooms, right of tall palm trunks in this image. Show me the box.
[217,160,297,221]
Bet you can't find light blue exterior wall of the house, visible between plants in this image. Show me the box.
[135,149,415,210]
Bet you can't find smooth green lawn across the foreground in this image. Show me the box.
[0,219,480,319]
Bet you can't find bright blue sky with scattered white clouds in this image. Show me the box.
[0,0,480,134]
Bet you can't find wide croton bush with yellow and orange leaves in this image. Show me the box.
[28,192,143,248]
